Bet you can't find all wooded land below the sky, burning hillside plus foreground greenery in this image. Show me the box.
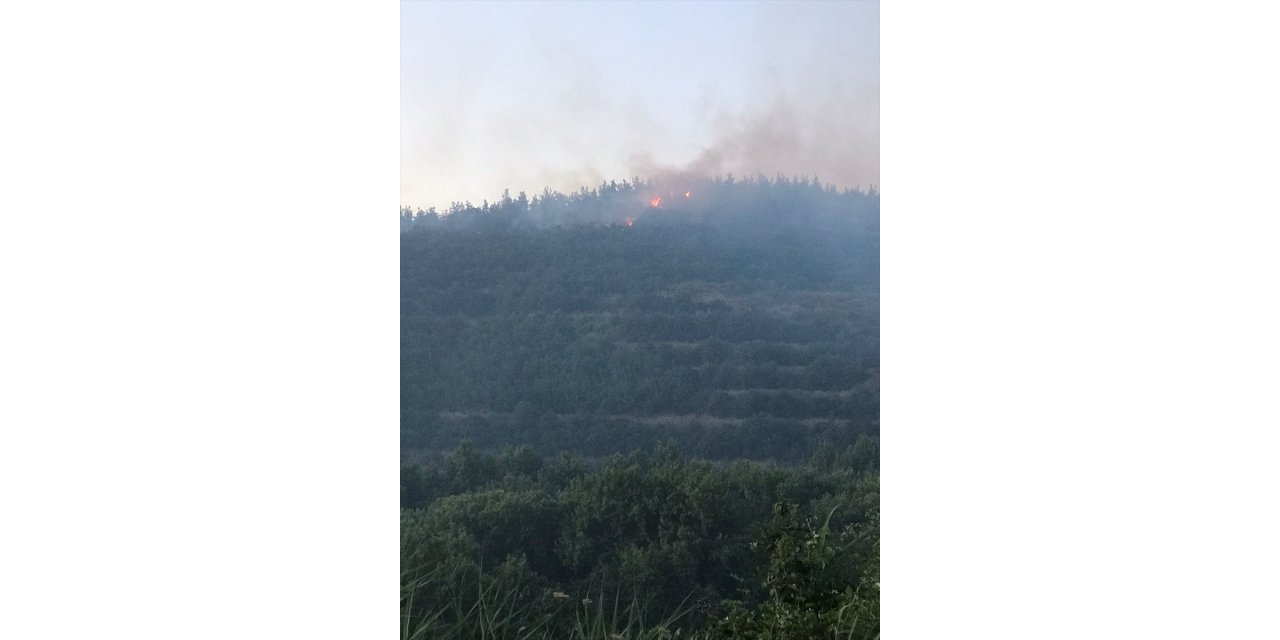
[401,177,879,639]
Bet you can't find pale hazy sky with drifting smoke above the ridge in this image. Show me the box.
[401,1,879,209]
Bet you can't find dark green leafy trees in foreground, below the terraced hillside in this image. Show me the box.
[401,444,878,639]
